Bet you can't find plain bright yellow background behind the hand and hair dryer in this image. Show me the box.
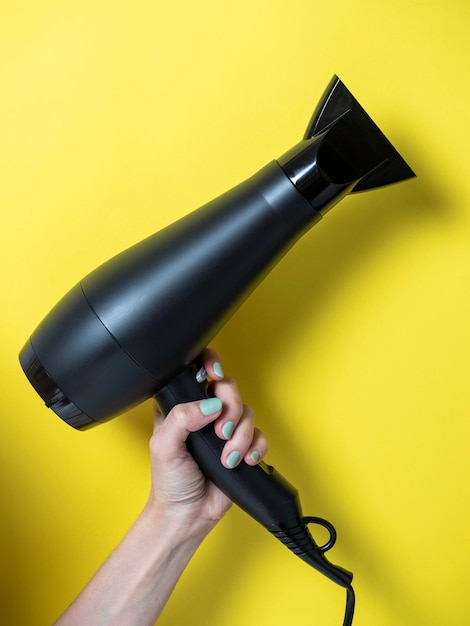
[0,0,470,626]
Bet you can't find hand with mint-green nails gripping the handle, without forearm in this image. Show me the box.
[143,350,267,537]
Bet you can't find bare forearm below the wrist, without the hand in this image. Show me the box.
[56,507,205,626]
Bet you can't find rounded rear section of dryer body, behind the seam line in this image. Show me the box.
[20,285,156,428]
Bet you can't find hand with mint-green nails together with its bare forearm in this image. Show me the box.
[52,350,267,626]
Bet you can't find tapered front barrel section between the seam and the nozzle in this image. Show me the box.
[82,161,319,386]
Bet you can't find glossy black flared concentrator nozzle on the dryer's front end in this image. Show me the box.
[278,76,415,216]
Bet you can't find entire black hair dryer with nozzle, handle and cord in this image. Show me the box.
[20,76,414,624]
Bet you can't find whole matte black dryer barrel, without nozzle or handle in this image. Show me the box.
[20,161,320,428]
